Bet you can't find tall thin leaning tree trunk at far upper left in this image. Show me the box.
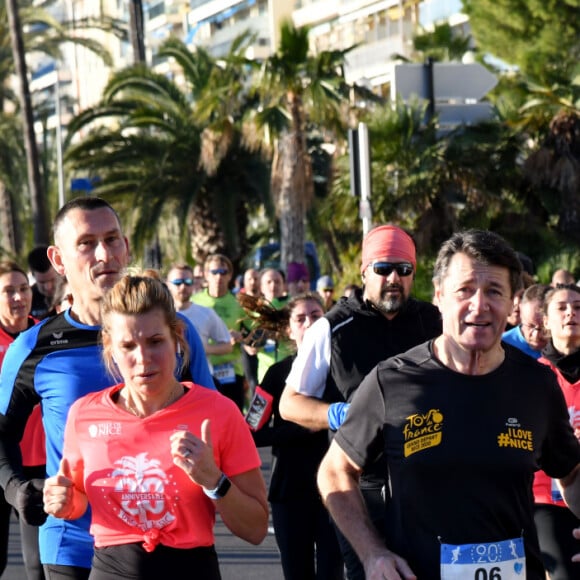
[6,0,49,245]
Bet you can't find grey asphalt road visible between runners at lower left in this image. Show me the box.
[1,447,284,580]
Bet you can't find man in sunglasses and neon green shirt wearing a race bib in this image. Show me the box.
[191,254,246,411]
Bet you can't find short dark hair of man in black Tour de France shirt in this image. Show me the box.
[433,229,522,296]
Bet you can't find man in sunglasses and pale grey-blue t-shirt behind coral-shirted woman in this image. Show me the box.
[166,264,233,369]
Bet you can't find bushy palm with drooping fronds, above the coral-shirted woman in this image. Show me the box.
[66,39,268,262]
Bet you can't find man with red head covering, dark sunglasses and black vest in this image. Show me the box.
[280,225,441,580]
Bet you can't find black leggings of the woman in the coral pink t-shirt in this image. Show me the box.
[89,543,221,580]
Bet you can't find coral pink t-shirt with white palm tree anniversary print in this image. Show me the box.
[64,383,260,551]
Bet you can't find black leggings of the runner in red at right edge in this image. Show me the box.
[534,504,580,580]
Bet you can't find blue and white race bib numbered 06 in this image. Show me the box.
[441,538,526,580]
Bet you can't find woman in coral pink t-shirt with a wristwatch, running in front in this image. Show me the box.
[44,276,268,580]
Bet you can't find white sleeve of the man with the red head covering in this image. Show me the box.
[286,317,330,399]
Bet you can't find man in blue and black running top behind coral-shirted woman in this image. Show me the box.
[0,197,213,580]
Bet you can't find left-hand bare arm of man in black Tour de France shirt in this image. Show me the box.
[317,441,416,580]
